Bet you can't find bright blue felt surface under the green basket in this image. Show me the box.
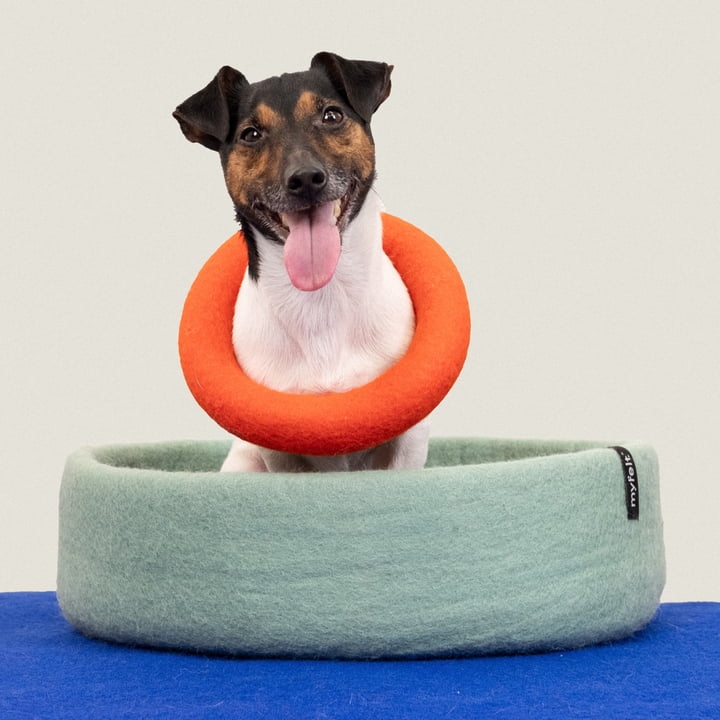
[0,593,720,720]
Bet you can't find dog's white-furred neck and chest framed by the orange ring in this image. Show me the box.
[234,192,414,392]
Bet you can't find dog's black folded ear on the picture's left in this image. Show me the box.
[173,65,249,150]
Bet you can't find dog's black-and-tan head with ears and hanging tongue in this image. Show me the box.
[173,52,392,290]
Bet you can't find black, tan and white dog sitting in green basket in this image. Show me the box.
[173,52,429,472]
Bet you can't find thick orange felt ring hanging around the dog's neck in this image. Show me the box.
[179,214,470,455]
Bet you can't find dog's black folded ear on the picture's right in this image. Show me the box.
[310,52,393,123]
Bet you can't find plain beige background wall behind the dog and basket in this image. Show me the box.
[0,0,720,601]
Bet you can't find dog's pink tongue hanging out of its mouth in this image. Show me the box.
[283,202,340,290]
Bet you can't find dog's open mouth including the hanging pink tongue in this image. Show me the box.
[255,193,350,291]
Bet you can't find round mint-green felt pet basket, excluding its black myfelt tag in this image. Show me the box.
[58,438,664,658]
